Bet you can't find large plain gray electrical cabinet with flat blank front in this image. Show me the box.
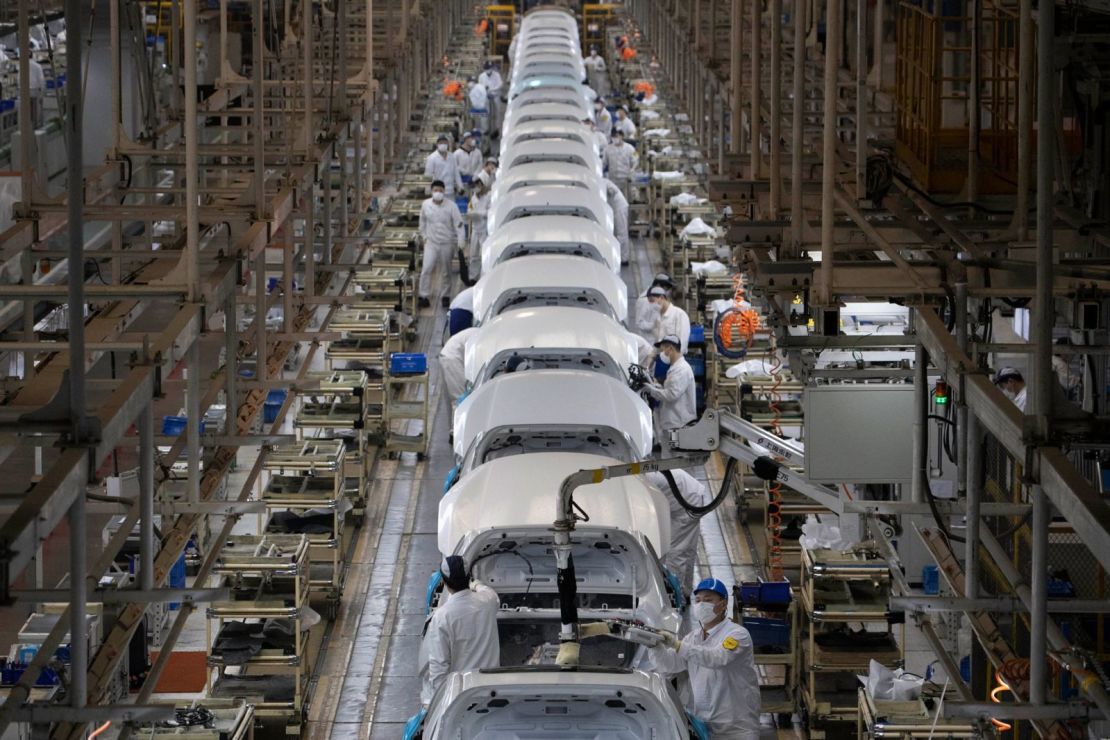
[805,383,914,484]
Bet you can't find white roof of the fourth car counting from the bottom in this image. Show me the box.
[464,306,638,384]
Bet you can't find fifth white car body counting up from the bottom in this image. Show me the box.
[473,254,628,324]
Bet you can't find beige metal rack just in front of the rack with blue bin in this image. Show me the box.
[293,371,371,517]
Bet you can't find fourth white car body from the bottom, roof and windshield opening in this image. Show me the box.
[463,306,638,387]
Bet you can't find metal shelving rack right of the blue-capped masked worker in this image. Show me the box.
[799,545,905,740]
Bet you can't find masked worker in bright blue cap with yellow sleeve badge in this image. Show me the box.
[652,578,759,740]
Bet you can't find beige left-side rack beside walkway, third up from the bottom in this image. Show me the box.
[262,439,349,618]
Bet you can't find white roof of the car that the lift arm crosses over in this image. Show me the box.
[438,453,670,557]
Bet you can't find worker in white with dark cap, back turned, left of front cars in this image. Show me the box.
[421,555,501,707]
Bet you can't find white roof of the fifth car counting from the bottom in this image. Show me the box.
[473,254,628,323]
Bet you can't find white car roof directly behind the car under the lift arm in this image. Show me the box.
[454,369,653,459]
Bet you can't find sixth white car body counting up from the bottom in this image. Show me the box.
[482,216,620,275]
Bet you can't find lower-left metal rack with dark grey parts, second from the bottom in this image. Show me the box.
[201,534,314,737]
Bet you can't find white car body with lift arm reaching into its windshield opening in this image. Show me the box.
[430,452,682,666]
